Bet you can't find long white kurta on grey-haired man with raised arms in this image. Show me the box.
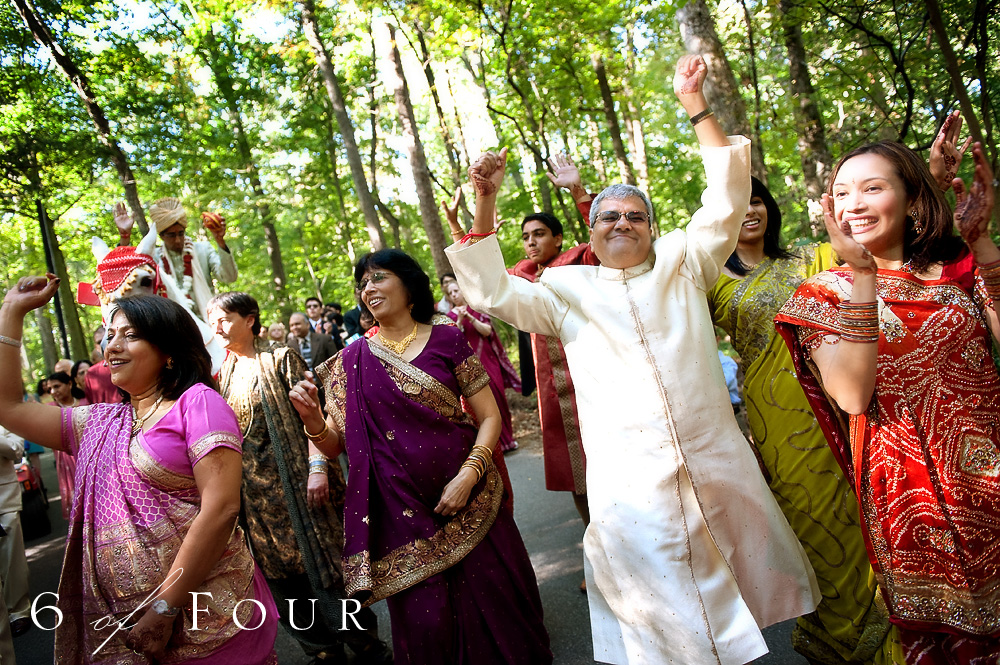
[447,137,819,665]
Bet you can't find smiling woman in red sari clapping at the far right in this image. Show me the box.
[777,142,1000,665]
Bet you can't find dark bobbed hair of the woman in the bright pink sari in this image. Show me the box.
[108,296,219,401]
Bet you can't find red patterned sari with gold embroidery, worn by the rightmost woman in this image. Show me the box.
[776,258,1000,665]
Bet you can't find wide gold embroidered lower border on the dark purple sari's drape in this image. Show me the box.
[344,461,503,605]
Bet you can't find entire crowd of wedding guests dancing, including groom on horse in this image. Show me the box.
[0,56,1000,665]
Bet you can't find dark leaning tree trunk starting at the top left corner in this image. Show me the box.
[13,0,149,235]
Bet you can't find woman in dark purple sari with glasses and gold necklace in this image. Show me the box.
[291,250,552,665]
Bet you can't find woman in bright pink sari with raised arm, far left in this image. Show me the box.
[0,282,277,665]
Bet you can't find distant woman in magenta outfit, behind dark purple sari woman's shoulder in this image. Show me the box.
[445,281,521,453]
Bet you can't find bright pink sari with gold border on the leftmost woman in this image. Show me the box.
[55,384,278,665]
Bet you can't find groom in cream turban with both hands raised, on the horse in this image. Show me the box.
[115,198,237,321]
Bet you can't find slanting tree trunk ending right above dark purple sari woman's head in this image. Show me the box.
[302,0,385,251]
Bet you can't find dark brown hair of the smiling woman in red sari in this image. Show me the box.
[826,141,965,272]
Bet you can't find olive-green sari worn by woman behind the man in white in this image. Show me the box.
[708,244,901,665]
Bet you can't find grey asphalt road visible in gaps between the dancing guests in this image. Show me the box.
[14,450,806,665]
